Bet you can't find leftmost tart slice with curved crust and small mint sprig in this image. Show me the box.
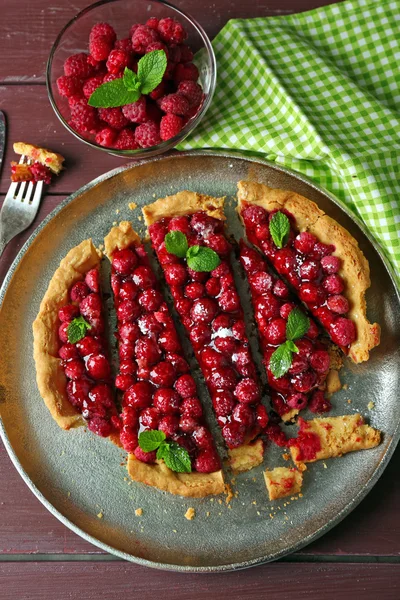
[33,240,119,443]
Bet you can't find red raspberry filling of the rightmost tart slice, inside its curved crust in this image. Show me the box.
[241,205,357,353]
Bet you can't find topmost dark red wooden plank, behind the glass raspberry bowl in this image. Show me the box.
[0,0,340,83]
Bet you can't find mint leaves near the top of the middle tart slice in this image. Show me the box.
[165,231,221,273]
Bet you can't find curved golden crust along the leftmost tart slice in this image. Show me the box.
[33,239,101,429]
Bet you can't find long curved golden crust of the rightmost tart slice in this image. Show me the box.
[238,181,380,363]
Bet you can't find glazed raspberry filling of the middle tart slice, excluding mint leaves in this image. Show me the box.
[149,212,268,448]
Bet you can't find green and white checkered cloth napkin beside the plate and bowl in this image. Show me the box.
[180,0,400,279]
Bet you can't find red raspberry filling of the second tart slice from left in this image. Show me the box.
[111,240,221,473]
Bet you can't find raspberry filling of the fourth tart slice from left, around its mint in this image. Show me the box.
[240,241,331,418]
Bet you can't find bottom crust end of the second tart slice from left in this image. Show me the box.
[127,454,225,498]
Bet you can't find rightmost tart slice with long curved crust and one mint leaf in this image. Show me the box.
[238,181,380,363]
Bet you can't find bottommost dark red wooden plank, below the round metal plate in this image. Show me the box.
[0,562,400,600]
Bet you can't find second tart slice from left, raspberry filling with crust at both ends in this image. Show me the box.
[104,221,224,497]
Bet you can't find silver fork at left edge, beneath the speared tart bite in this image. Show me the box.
[0,155,43,256]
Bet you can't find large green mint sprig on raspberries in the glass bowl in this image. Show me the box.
[88,50,167,108]
